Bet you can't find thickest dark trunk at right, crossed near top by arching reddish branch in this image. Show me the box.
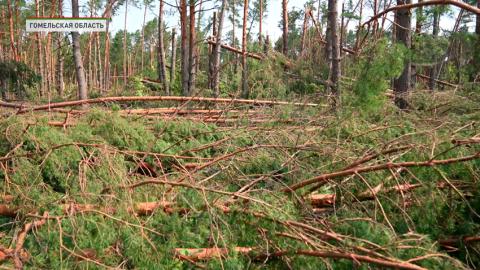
[393,0,411,109]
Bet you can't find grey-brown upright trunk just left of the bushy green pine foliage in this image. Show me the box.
[328,0,340,107]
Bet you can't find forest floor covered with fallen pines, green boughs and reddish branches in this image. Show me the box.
[0,91,480,269]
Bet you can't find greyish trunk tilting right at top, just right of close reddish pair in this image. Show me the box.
[210,0,227,97]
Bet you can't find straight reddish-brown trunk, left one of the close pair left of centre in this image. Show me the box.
[180,0,190,96]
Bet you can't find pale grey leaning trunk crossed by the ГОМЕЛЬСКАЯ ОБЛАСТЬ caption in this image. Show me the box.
[72,0,87,108]
